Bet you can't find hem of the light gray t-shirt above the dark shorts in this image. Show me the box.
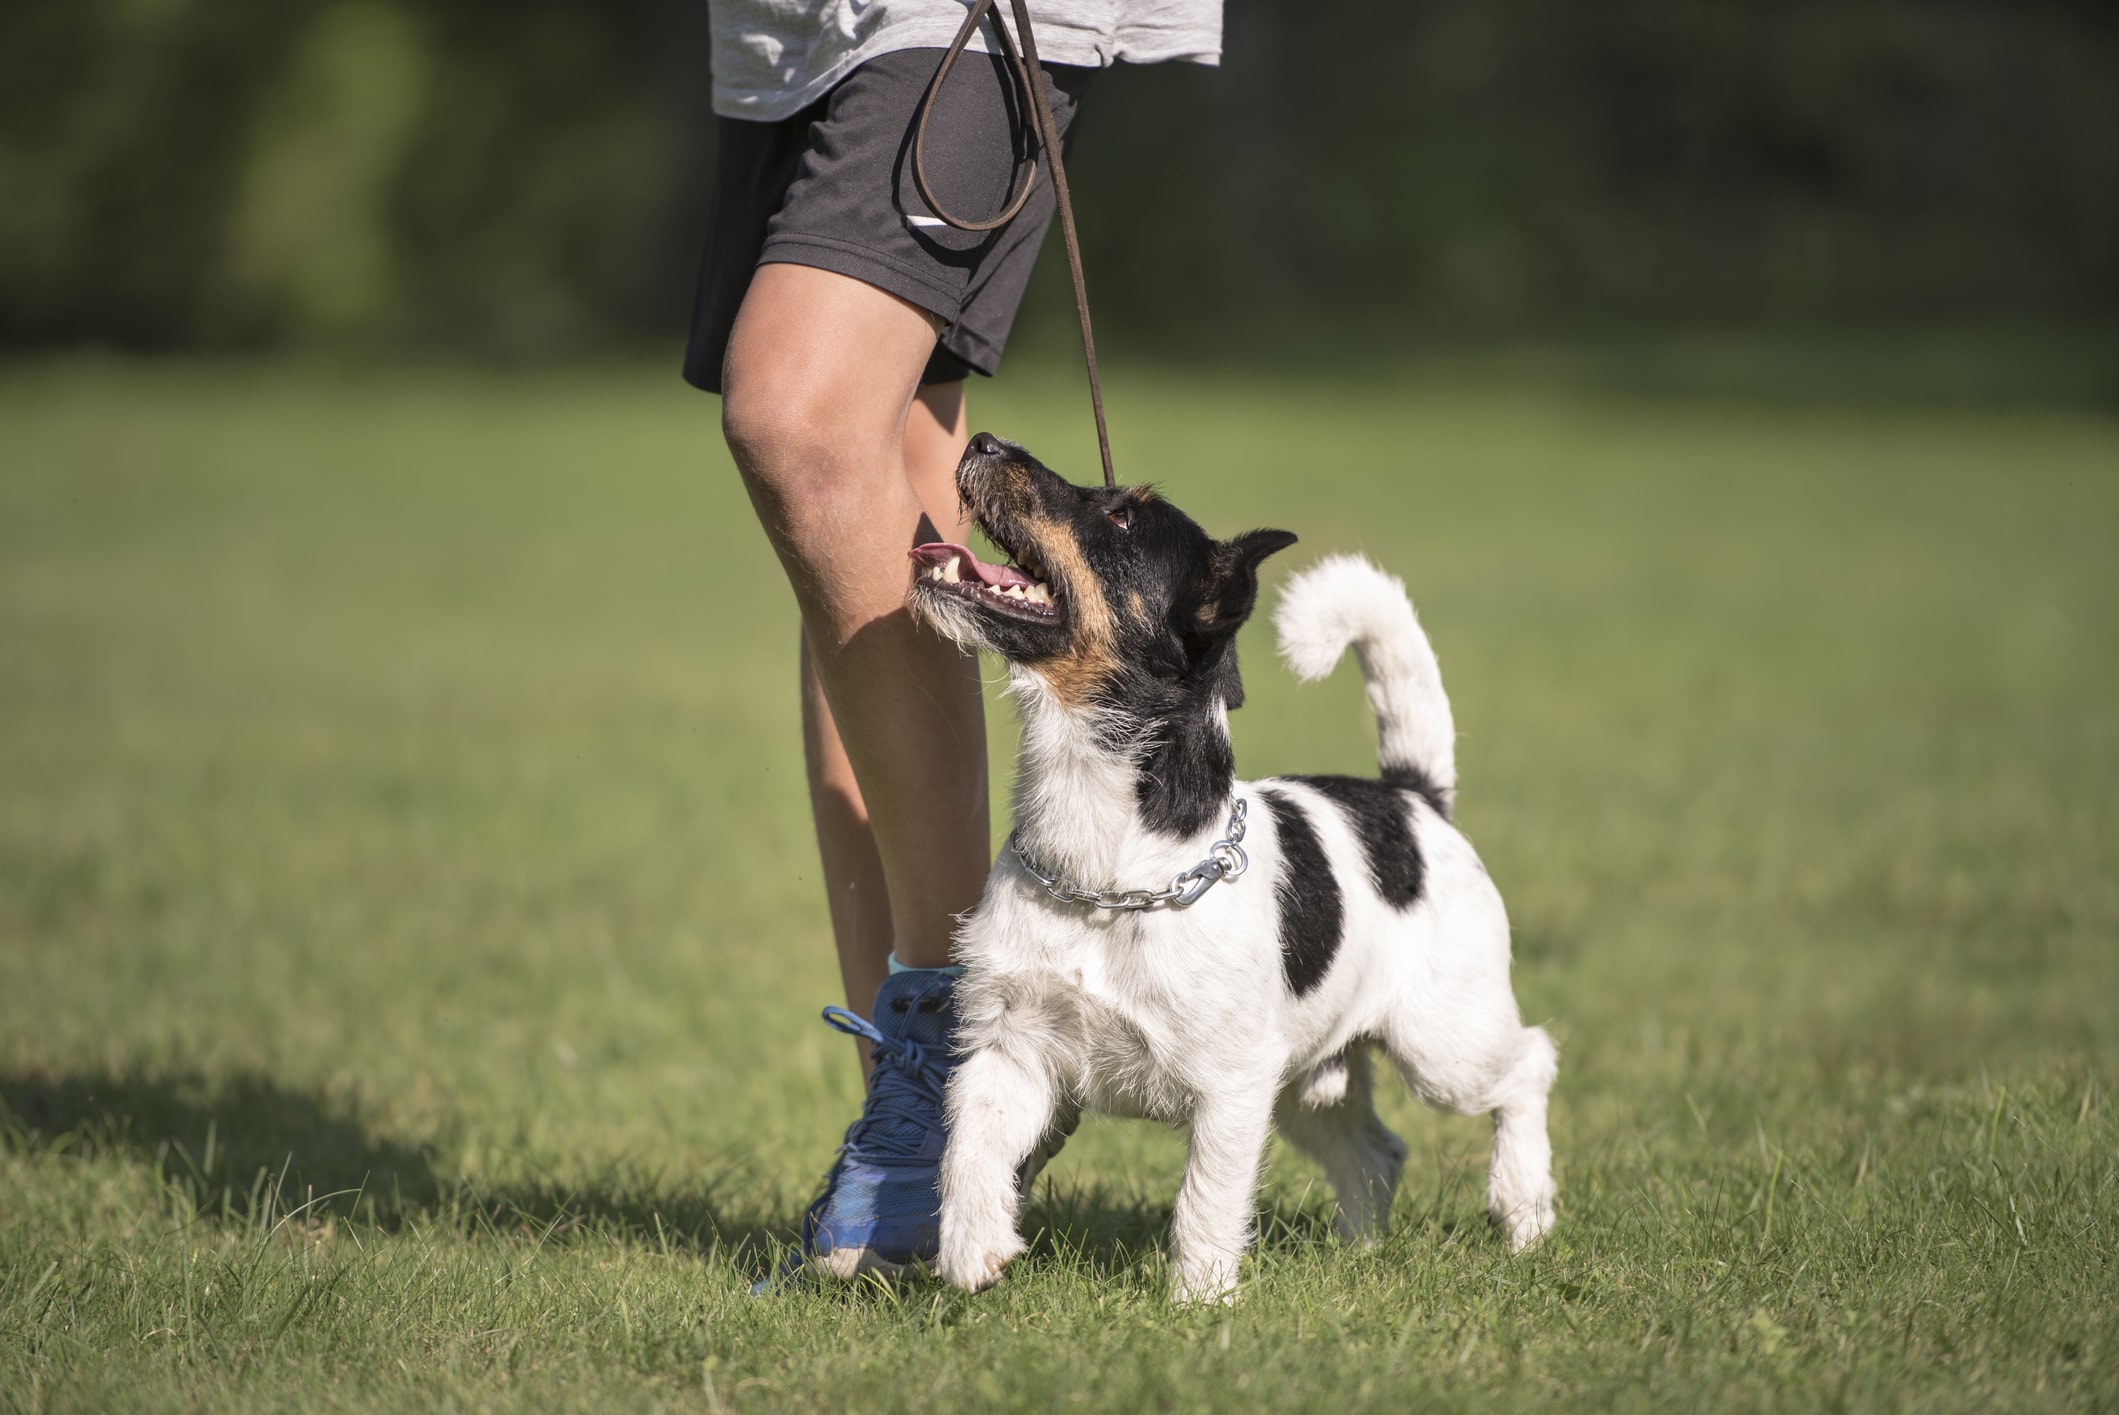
[708,0,1221,123]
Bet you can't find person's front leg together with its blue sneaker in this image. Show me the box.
[720,263,987,1286]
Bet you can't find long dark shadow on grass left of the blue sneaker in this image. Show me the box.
[0,1070,799,1271]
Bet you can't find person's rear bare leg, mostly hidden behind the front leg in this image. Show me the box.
[801,383,985,1054]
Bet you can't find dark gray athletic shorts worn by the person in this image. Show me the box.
[684,49,1096,392]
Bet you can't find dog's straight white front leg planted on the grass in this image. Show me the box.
[1170,1078,1274,1303]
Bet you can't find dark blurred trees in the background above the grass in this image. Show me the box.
[0,0,2119,356]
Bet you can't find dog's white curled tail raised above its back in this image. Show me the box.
[1274,555,1456,816]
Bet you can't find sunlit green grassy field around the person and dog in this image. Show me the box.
[0,364,2119,1411]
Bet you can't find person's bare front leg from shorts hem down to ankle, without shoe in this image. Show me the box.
[723,265,987,982]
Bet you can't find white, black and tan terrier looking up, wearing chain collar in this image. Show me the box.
[909,432,1557,1303]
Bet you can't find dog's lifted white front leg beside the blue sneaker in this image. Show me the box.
[939,1046,1055,1292]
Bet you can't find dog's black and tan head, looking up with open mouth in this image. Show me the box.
[911,432,1295,708]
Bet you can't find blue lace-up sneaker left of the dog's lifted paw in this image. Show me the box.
[782,968,958,1279]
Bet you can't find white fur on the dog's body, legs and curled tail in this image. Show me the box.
[939,557,1555,1301]
